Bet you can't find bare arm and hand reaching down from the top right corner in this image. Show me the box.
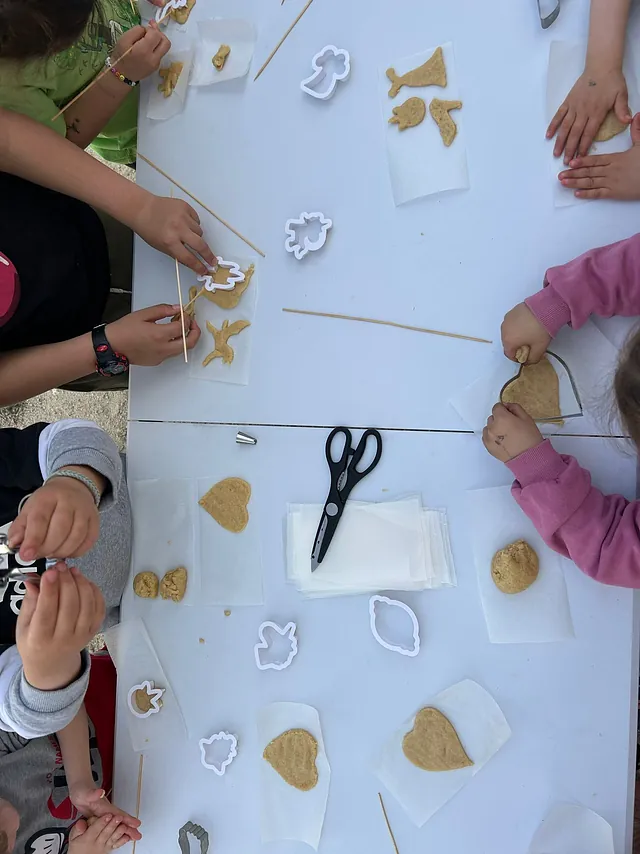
[547,0,631,164]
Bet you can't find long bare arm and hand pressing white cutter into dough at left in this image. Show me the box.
[0,108,215,274]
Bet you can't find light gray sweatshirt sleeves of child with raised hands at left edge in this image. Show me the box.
[0,421,131,744]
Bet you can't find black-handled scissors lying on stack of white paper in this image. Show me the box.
[311,427,382,572]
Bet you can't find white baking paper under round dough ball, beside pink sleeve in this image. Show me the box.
[467,486,574,643]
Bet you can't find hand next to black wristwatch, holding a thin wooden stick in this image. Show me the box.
[105,305,200,366]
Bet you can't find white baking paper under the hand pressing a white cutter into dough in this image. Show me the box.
[189,258,258,385]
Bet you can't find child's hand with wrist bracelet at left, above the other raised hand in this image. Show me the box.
[9,466,104,563]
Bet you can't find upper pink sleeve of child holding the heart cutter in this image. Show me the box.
[525,234,640,336]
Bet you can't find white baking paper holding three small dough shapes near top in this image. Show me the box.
[379,42,469,205]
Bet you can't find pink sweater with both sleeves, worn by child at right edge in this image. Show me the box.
[507,234,640,588]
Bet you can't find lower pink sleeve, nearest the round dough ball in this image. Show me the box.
[507,439,640,588]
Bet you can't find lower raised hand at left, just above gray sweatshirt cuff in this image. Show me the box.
[16,563,105,691]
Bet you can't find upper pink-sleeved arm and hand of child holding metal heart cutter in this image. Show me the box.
[502,234,640,362]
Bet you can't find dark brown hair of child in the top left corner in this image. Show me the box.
[0,0,99,62]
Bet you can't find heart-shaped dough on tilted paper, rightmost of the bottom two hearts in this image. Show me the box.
[402,706,473,771]
